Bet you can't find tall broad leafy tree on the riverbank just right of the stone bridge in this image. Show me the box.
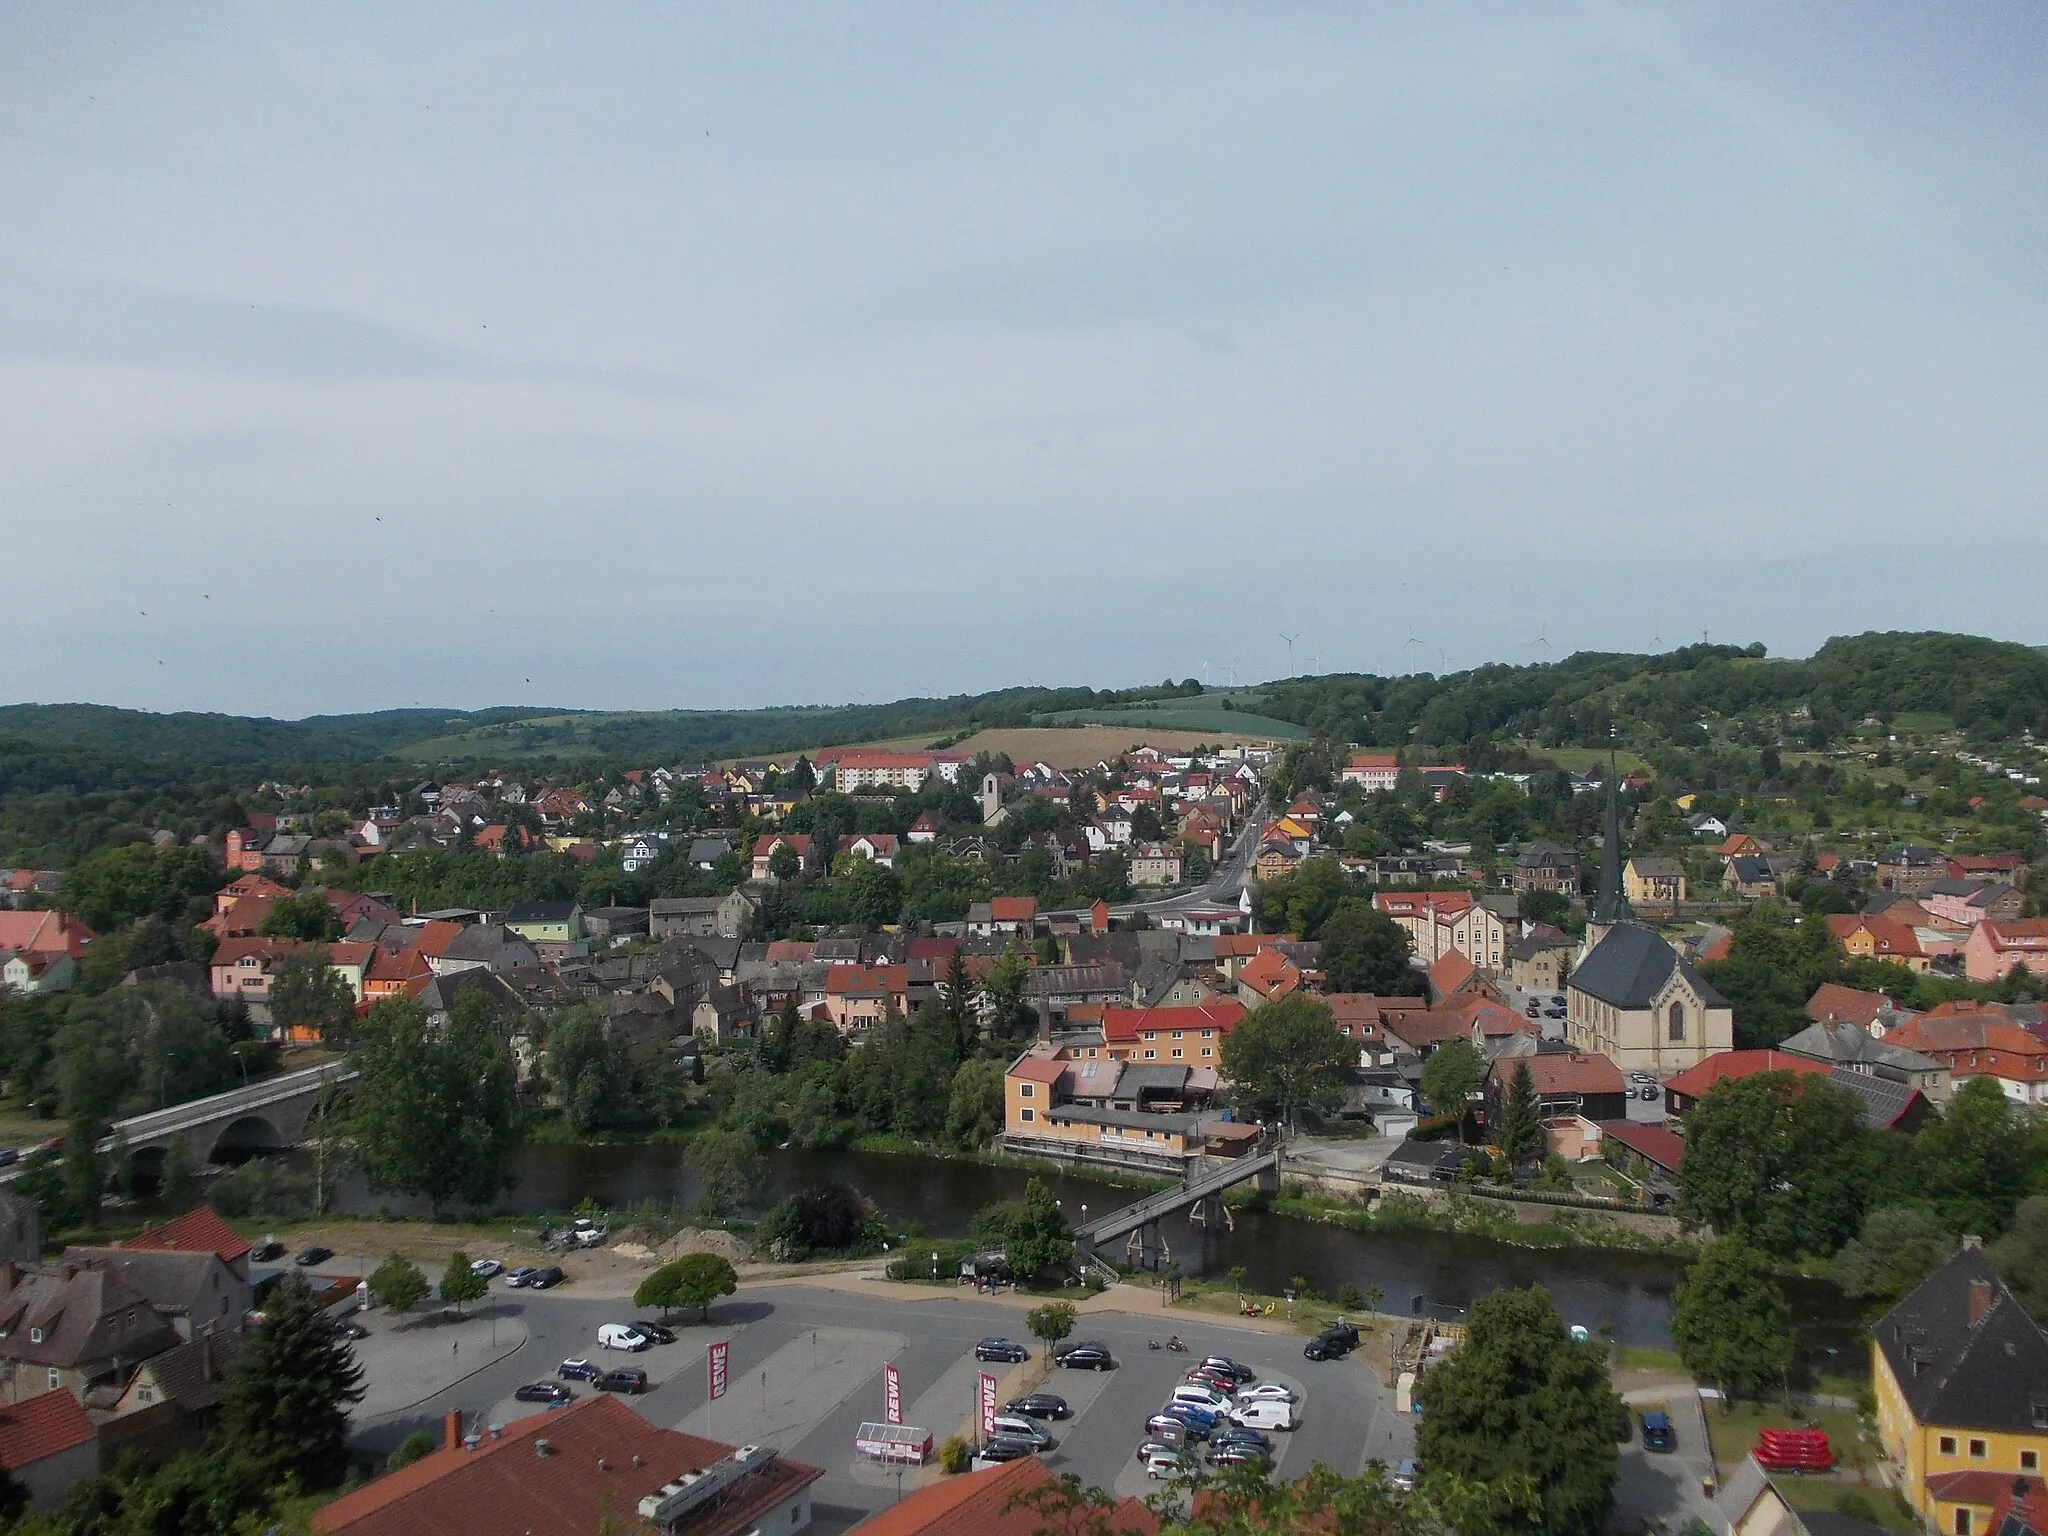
[354,987,518,1210]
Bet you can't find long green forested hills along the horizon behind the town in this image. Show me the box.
[0,633,2048,791]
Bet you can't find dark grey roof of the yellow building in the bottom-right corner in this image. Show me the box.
[1876,1245,2048,1434]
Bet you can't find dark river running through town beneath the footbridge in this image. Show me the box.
[292,1143,1862,1360]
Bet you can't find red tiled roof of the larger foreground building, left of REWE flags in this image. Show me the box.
[313,1393,823,1536]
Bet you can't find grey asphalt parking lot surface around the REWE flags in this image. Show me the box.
[356,1284,1411,1536]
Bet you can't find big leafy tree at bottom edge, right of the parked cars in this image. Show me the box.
[1415,1286,1622,1536]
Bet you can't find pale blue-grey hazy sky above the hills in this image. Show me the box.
[0,0,2048,717]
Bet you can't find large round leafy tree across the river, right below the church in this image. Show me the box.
[1679,1071,1882,1260]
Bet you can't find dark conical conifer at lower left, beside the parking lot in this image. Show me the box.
[221,1274,362,1489]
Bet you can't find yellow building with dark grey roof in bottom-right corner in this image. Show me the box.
[1870,1237,2048,1536]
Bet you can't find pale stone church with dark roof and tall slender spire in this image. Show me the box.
[1565,766,1735,1079]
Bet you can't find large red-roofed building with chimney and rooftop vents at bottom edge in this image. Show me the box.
[311,1393,823,1536]
